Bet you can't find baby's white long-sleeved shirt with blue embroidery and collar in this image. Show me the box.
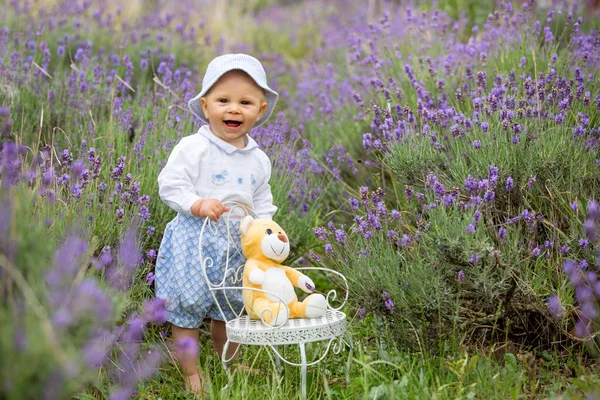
[158,125,277,219]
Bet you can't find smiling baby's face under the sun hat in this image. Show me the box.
[200,70,267,149]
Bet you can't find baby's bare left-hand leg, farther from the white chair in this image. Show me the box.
[171,325,204,393]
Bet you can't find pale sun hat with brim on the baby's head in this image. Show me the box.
[188,53,279,127]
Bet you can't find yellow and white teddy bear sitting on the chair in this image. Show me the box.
[240,216,327,326]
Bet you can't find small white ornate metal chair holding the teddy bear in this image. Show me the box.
[199,203,353,399]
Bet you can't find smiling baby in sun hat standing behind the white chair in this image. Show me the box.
[155,54,278,394]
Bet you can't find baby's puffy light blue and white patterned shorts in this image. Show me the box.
[155,213,246,328]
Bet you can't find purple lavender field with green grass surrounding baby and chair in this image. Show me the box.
[0,0,600,400]
